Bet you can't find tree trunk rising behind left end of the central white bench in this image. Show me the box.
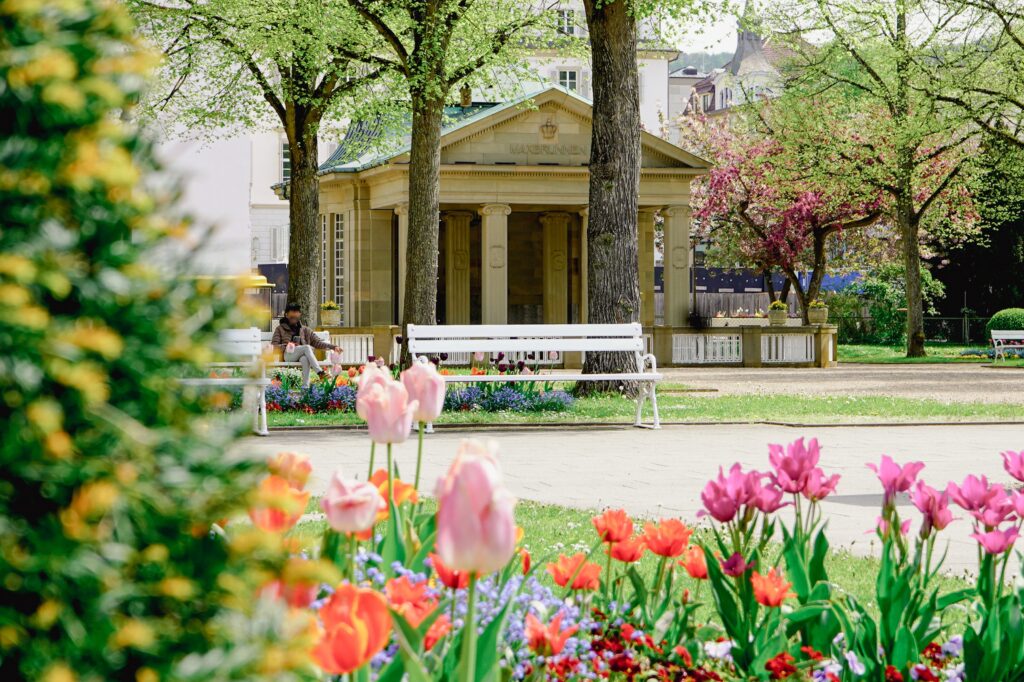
[400,92,444,365]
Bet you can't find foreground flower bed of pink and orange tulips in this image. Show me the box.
[241,358,1024,682]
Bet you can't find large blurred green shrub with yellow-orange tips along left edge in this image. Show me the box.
[0,0,294,681]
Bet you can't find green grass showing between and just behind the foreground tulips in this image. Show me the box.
[292,499,968,617]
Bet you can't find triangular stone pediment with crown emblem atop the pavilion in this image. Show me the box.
[441,87,709,170]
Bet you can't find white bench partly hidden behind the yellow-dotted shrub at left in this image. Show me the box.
[181,327,270,435]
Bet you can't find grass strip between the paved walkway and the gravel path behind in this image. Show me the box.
[268,388,1021,427]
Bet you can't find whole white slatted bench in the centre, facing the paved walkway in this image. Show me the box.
[407,323,662,429]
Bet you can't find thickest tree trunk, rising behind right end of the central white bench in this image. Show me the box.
[579,0,638,395]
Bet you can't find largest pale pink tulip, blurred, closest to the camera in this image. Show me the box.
[437,440,516,574]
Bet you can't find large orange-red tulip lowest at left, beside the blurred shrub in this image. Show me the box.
[313,584,391,675]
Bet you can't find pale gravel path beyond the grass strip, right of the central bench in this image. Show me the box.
[663,364,1024,401]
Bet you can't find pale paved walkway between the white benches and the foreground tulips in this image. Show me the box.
[239,419,1024,571]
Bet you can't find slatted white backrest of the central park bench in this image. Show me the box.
[408,323,644,355]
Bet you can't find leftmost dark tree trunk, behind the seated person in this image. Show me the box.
[288,133,324,325]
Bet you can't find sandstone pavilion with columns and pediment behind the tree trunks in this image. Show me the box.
[319,87,708,327]
